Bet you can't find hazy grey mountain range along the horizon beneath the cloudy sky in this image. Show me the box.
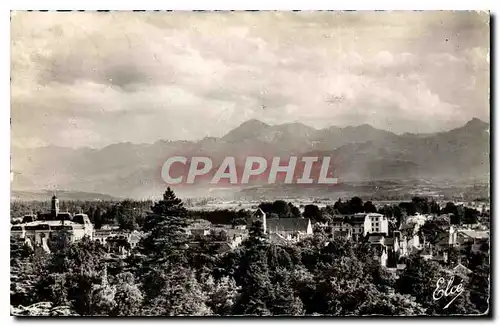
[11,118,490,198]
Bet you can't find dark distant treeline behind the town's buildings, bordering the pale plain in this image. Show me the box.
[11,197,489,230]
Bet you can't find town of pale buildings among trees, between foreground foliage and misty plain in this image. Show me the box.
[11,188,490,311]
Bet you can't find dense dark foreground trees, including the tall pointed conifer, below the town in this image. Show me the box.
[11,189,490,316]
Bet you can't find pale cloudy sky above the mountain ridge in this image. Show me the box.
[11,11,490,148]
